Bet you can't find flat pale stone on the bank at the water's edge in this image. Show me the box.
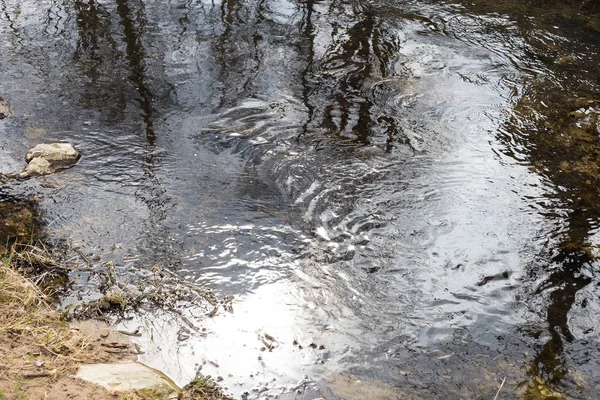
[76,362,180,399]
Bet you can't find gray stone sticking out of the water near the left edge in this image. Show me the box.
[19,143,80,178]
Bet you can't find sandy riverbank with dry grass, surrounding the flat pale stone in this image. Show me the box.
[0,246,229,400]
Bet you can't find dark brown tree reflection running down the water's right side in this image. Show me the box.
[468,2,598,391]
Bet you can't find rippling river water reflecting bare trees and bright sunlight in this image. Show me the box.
[0,0,600,399]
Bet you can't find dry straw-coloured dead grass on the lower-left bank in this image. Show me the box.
[0,248,144,400]
